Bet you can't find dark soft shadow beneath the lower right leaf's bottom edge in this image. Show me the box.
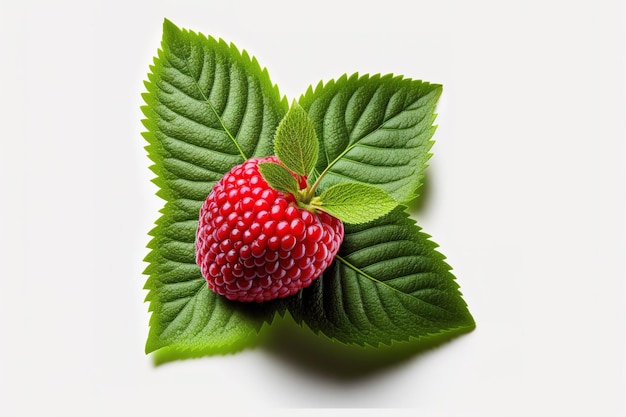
[258,315,472,382]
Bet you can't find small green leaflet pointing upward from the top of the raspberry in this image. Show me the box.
[274,101,318,175]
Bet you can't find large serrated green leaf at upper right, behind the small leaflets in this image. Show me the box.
[299,74,441,204]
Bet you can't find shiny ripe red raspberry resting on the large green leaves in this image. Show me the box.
[196,156,344,302]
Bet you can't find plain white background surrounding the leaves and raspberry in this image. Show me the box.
[0,0,626,416]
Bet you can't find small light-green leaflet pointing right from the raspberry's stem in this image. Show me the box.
[316,182,398,224]
